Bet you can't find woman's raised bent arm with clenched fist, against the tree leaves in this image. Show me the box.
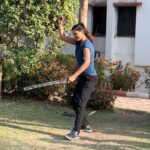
[58,16,76,44]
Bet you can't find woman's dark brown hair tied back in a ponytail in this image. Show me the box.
[72,23,94,43]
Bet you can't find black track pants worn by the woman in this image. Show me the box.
[72,75,98,132]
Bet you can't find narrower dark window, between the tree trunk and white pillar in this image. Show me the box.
[93,7,106,36]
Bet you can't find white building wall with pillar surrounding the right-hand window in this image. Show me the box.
[105,0,150,67]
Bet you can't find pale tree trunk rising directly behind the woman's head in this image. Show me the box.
[79,0,88,26]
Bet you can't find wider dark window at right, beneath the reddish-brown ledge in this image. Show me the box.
[117,7,136,37]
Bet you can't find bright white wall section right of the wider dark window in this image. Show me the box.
[134,0,150,66]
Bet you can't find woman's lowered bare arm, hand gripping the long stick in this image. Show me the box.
[69,48,90,82]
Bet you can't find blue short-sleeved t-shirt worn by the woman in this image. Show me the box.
[75,39,97,76]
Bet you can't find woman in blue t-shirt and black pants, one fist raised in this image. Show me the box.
[58,16,98,140]
